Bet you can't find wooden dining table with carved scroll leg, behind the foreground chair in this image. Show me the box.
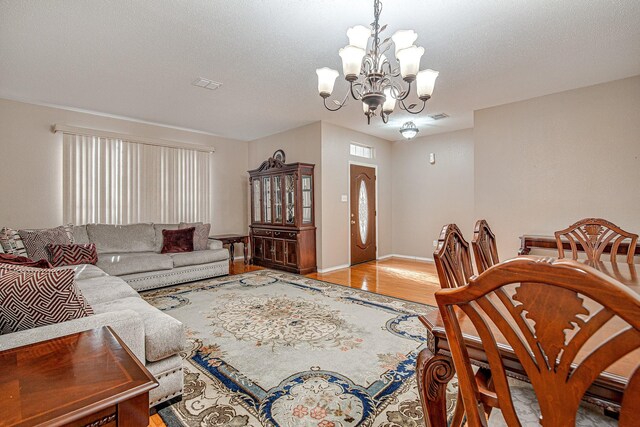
[416,256,640,427]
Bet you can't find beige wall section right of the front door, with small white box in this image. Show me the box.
[392,129,475,259]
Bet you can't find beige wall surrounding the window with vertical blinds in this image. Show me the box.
[0,99,248,233]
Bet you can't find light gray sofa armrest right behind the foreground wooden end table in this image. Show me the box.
[0,310,145,364]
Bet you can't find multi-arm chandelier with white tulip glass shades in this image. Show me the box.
[316,0,438,123]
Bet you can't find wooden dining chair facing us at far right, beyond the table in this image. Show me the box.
[555,218,638,264]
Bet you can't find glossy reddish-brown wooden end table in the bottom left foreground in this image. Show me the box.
[0,327,158,427]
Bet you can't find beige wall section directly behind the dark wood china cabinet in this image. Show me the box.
[246,122,322,266]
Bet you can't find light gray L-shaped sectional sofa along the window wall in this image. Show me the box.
[0,224,229,406]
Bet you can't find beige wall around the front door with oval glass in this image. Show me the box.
[319,122,392,270]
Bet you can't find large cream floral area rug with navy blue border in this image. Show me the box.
[143,270,458,427]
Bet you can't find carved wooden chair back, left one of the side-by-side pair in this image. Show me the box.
[433,224,473,288]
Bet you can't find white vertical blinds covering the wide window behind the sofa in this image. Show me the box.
[63,133,213,224]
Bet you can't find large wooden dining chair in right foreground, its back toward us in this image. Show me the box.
[436,258,640,427]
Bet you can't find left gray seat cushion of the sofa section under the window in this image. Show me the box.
[96,252,173,276]
